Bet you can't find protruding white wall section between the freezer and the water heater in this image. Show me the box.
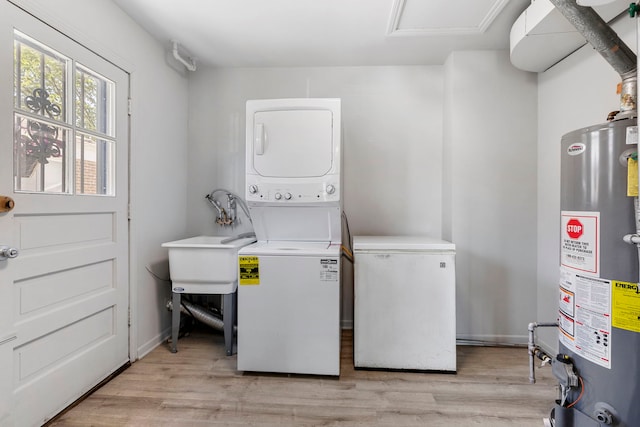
[443,51,536,343]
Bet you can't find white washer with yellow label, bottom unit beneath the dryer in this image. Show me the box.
[238,241,341,375]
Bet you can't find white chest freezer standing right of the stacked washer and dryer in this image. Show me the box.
[353,236,456,371]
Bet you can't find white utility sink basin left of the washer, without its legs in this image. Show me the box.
[162,236,256,294]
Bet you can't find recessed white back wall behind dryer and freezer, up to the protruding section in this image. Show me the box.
[188,66,442,326]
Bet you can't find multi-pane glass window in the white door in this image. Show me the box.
[14,31,115,196]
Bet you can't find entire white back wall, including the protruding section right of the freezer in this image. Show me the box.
[188,61,536,342]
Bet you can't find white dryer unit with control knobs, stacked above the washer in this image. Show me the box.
[245,98,342,211]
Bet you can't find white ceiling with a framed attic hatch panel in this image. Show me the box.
[113,0,530,67]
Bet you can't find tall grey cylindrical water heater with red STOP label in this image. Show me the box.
[552,118,640,427]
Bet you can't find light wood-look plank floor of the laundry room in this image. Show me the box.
[49,331,557,427]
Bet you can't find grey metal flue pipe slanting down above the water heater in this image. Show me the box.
[550,0,637,111]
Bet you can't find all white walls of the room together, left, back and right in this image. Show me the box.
[17,0,635,354]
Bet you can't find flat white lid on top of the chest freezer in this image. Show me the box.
[353,236,456,252]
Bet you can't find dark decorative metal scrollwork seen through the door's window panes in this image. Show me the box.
[20,88,65,176]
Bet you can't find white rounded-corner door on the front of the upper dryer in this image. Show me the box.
[251,110,334,178]
